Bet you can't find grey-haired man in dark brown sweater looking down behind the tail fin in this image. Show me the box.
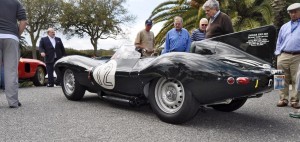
[202,0,233,38]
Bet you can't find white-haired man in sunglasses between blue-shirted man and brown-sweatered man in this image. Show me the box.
[191,18,208,42]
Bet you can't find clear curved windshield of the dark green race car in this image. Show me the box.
[111,45,141,59]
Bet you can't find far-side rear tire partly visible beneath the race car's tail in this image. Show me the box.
[211,98,247,112]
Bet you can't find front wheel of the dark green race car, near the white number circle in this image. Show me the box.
[61,69,85,101]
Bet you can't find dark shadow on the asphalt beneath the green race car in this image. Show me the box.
[57,94,300,140]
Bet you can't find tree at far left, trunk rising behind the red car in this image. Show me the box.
[20,0,60,59]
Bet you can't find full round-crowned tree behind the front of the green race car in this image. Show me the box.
[59,0,135,55]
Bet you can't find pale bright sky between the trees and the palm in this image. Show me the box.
[42,0,163,50]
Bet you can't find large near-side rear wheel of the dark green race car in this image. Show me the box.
[149,78,199,124]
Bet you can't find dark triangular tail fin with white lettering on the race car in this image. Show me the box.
[210,25,276,63]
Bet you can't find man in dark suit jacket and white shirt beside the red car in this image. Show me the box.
[39,28,66,87]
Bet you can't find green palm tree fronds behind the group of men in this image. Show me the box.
[150,0,273,47]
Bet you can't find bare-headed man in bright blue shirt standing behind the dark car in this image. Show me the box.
[162,16,191,54]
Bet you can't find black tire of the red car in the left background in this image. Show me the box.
[32,66,46,86]
